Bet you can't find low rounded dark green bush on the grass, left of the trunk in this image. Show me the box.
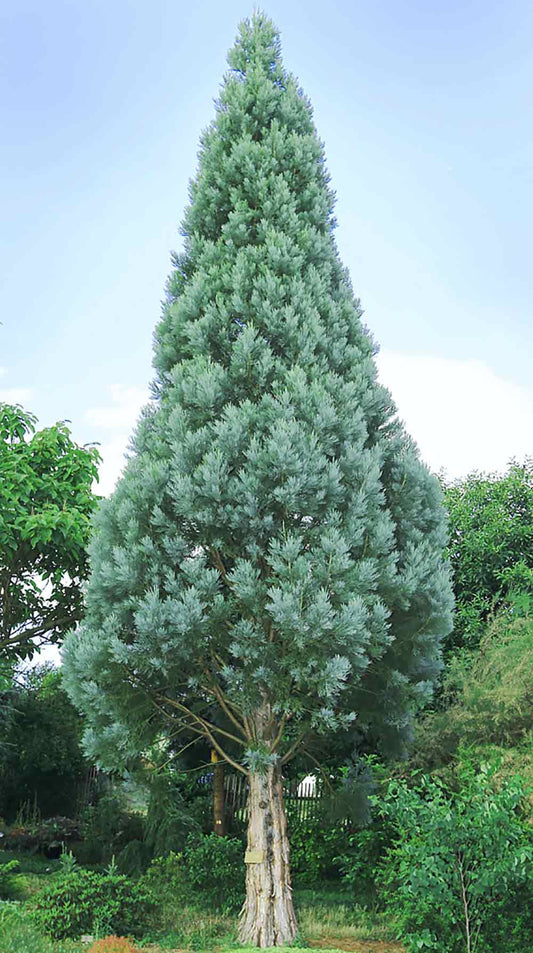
[34,870,154,940]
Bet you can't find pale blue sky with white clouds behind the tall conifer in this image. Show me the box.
[0,0,533,490]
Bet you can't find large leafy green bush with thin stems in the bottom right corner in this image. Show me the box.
[381,767,533,953]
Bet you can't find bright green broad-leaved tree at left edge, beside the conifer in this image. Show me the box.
[0,404,100,662]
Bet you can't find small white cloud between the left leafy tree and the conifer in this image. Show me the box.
[85,384,149,496]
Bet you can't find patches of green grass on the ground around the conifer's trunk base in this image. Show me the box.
[0,851,405,953]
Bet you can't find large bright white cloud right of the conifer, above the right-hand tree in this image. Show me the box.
[377,351,533,477]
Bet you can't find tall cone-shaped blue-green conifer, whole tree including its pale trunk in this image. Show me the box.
[64,14,451,946]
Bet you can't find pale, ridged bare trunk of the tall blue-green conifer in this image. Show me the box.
[239,764,298,947]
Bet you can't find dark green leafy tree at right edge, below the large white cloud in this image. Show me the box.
[445,460,533,650]
